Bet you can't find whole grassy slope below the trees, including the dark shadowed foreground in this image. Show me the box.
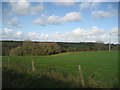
[3,51,118,88]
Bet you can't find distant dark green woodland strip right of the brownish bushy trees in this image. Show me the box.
[58,42,118,51]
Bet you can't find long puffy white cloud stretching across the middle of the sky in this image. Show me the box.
[33,12,83,26]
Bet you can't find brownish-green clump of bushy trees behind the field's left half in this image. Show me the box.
[2,41,62,56]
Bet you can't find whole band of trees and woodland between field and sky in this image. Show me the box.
[2,41,118,56]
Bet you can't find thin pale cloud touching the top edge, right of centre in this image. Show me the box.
[79,2,100,10]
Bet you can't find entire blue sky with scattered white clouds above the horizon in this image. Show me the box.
[0,0,118,43]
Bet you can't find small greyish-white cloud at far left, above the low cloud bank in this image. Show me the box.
[6,17,22,28]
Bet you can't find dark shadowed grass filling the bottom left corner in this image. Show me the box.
[3,68,69,88]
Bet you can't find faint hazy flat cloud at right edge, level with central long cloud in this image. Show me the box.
[92,11,117,19]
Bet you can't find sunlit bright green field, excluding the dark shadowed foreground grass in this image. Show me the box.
[2,51,118,87]
